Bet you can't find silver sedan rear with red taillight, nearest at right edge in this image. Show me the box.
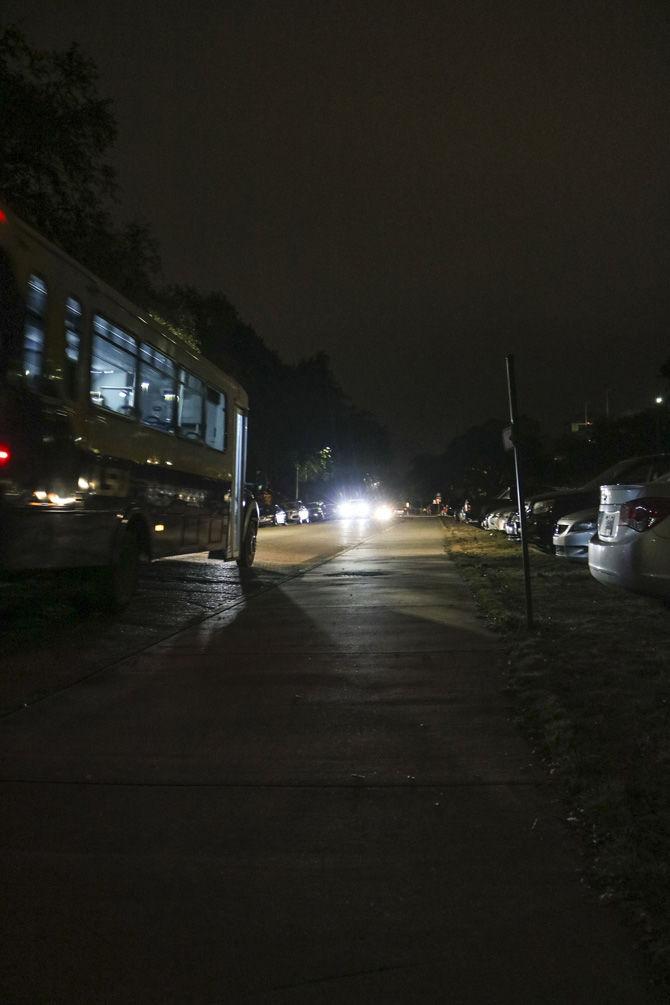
[589,474,670,600]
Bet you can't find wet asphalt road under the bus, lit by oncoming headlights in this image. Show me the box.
[0,521,379,715]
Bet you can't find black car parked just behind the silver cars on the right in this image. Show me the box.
[526,453,670,551]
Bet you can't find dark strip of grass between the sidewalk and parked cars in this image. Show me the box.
[445,523,670,989]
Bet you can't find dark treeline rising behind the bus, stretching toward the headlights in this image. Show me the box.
[0,26,390,494]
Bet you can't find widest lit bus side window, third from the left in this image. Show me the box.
[90,315,138,415]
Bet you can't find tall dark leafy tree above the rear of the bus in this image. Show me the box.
[0,25,160,298]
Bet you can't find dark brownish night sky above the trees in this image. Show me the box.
[4,0,670,460]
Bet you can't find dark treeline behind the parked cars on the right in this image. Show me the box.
[409,399,670,505]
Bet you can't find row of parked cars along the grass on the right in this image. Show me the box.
[466,453,670,600]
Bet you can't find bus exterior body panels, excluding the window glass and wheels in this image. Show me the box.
[0,204,257,569]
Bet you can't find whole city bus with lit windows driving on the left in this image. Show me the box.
[0,207,258,607]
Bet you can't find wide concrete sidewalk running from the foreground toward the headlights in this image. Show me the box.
[0,520,656,1005]
